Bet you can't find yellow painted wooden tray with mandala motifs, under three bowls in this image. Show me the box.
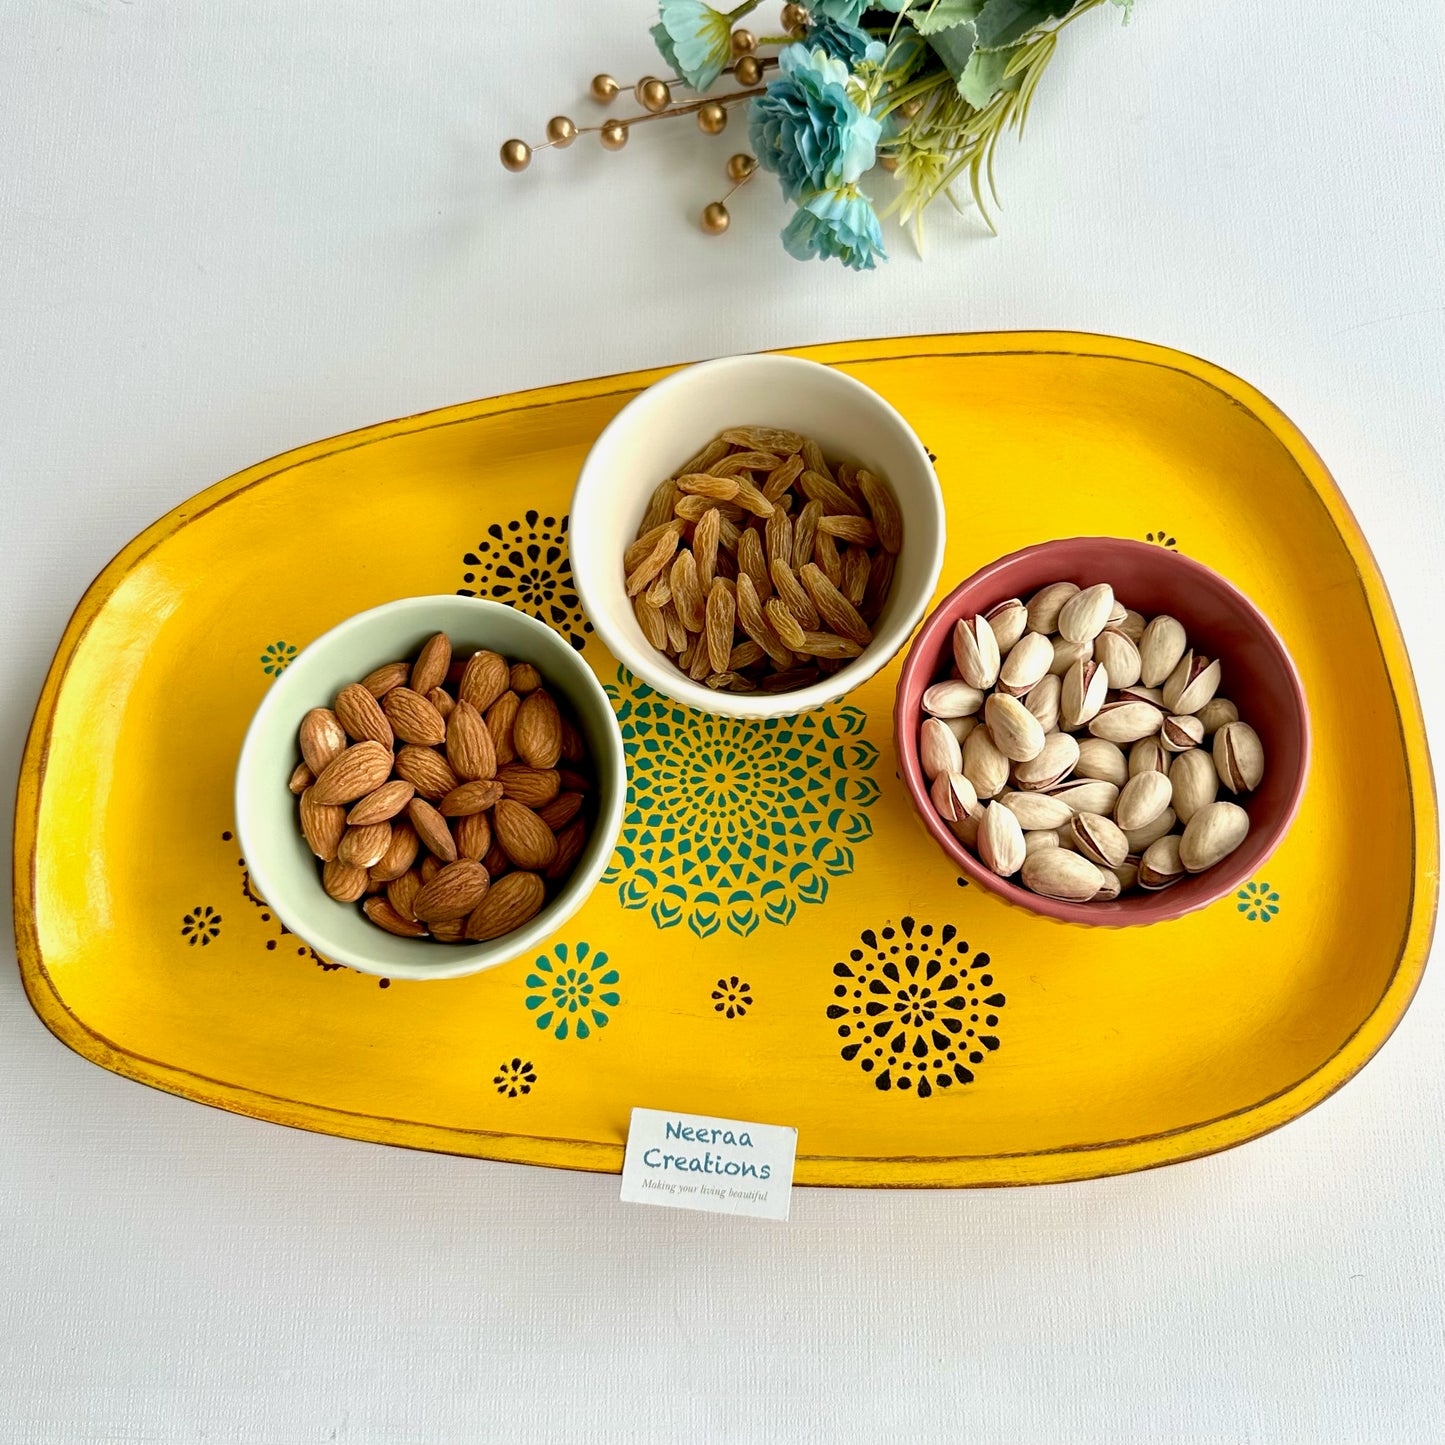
[14,334,1438,1186]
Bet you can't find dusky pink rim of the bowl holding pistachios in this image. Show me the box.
[893,536,1312,928]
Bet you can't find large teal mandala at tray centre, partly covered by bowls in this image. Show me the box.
[603,668,879,938]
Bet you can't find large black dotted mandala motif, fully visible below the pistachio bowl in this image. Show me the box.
[828,918,1006,1098]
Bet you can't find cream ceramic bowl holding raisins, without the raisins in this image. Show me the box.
[569,355,944,718]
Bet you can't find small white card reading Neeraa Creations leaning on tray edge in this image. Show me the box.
[621,1108,798,1220]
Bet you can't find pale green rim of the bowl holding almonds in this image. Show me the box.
[233,592,627,981]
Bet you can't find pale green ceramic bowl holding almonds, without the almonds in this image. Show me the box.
[236,595,627,978]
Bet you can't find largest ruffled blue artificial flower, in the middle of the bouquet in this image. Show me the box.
[749,45,881,201]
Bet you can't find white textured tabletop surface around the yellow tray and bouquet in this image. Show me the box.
[0,0,1445,1445]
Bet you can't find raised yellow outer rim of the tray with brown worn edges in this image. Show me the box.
[13,331,1439,1188]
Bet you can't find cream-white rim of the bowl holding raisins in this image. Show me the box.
[569,351,948,718]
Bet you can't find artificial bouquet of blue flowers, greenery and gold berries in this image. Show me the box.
[501,0,1133,270]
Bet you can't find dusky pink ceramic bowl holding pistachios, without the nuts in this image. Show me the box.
[893,538,1309,928]
